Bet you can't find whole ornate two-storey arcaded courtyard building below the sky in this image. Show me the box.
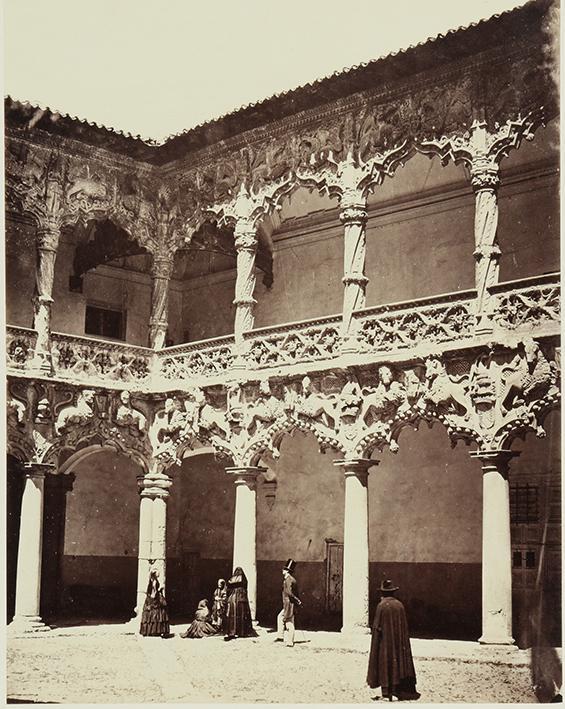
[5,0,560,643]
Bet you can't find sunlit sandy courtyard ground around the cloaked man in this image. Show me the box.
[7,628,536,704]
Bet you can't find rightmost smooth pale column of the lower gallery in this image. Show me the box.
[471,450,518,645]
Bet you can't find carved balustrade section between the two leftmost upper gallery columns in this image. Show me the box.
[51,333,154,386]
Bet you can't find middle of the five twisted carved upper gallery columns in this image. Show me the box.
[233,218,258,366]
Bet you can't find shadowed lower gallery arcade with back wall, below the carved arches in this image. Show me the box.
[7,411,561,647]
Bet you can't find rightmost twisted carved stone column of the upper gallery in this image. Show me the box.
[471,144,501,330]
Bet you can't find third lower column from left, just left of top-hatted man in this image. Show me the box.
[226,467,266,622]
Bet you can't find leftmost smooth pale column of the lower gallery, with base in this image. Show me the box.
[10,463,52,633]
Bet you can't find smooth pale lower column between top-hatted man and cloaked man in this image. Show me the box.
[334,458,378,633]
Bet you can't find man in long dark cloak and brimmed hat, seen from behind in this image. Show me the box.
[367,580,420,701]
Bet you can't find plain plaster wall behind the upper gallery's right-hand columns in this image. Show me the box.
[183,168,559,341]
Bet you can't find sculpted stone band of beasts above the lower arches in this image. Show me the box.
[7,338,560,471]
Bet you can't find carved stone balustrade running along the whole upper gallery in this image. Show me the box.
[6,274,560,392]
